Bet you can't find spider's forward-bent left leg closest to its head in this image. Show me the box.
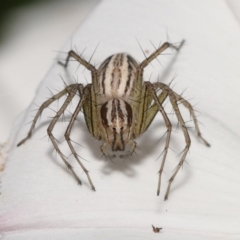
[64,86,95,191]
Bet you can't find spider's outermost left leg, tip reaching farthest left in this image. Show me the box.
[17,84,78,147]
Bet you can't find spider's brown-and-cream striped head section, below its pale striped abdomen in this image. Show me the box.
[101,99,135,158]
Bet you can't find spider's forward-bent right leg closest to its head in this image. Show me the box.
[145,82,172,196]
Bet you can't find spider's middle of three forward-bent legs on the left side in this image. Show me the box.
[47,87,82,184]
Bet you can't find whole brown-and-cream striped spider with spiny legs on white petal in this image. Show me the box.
[17,40,210,200]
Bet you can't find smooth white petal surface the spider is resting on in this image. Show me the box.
[0,0,240,239]
